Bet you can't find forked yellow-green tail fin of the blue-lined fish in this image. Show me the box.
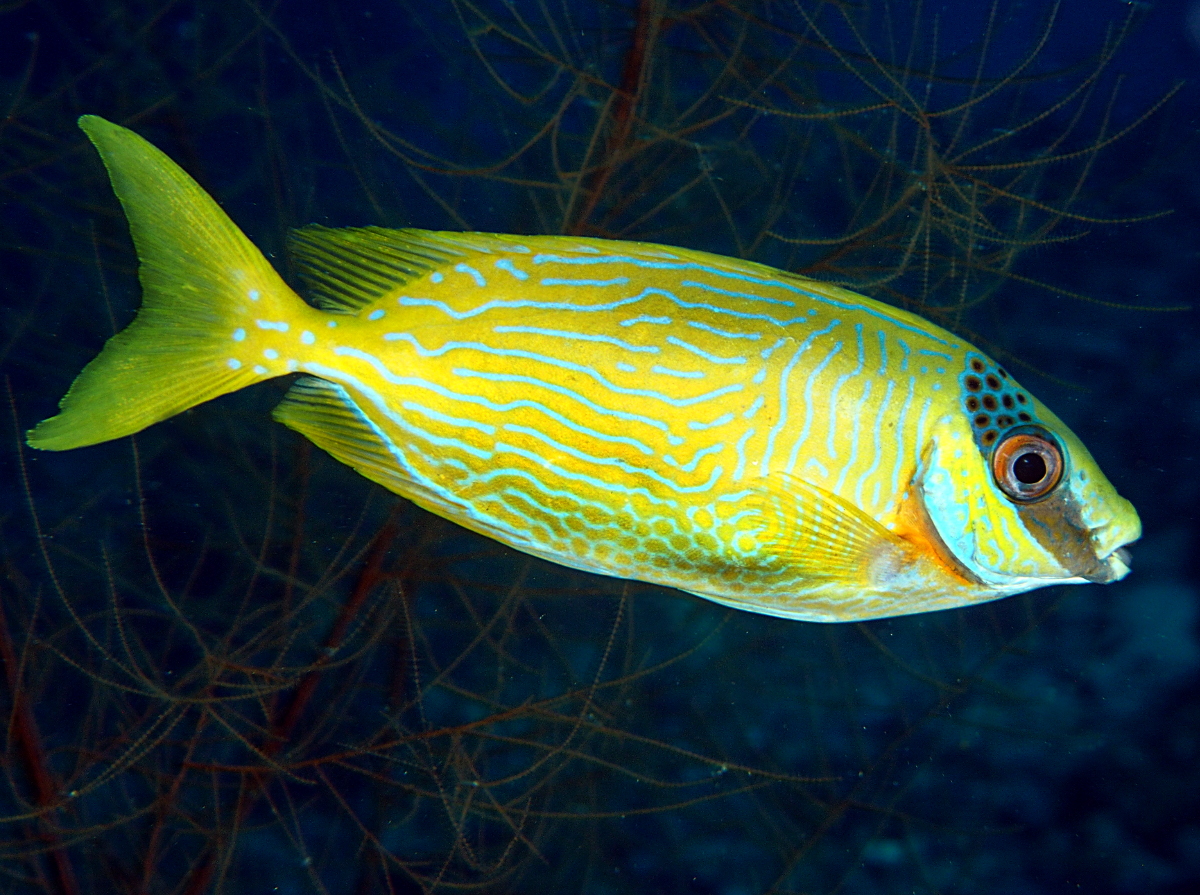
[26,115,302,451]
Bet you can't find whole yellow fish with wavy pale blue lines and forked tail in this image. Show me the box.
[26,115,1141,621]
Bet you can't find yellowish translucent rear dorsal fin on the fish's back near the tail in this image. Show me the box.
[288,224,464,313]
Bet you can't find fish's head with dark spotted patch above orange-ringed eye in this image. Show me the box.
[918,353,1141,599]
